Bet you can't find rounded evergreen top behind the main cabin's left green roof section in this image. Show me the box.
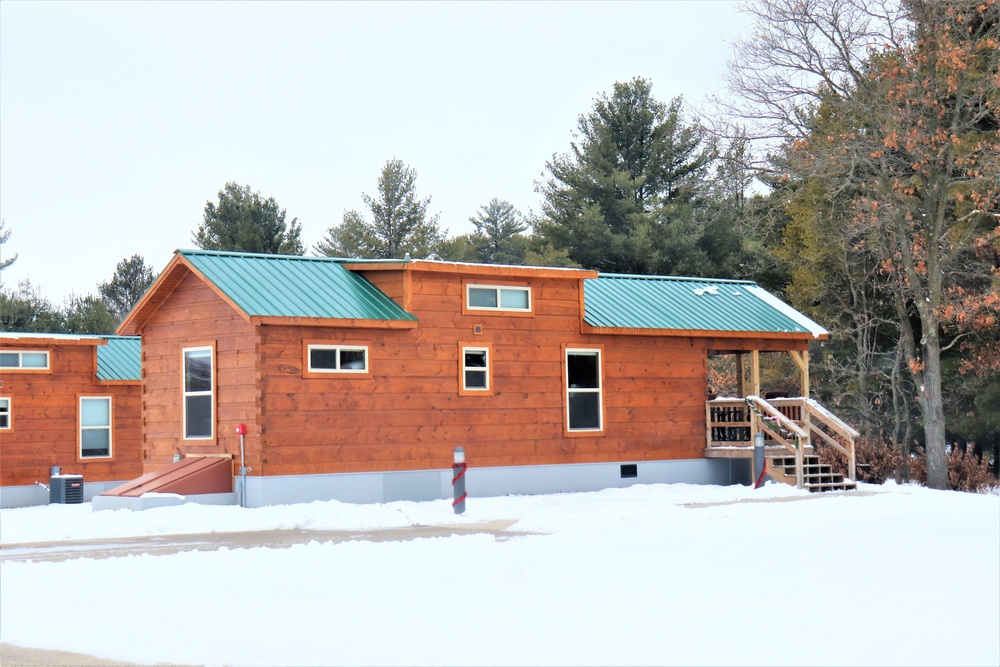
[191,182,304,255]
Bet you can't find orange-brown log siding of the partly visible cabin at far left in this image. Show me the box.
[0,339,142,486]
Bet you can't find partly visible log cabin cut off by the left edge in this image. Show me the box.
[0,333,142,507]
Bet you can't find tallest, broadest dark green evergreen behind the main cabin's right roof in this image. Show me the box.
[537,78,712,273]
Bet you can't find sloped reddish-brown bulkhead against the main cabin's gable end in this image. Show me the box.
[101,454,233,498]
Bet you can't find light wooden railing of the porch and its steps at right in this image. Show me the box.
[705,396,858,486]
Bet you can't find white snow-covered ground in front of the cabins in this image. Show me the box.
[0,484,1000,665]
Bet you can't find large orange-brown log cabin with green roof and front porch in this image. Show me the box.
[111,250,860,507]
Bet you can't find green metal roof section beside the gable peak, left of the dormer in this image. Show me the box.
[177,250,417,320]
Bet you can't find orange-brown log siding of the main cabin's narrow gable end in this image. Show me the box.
[142,273,260,472]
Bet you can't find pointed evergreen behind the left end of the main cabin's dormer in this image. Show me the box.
[316,159,444,259]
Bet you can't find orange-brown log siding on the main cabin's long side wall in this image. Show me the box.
[254,270,707,475]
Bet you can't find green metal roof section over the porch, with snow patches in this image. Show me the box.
[583,274,828,337]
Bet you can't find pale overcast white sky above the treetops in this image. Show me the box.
[0,0,745,305]
